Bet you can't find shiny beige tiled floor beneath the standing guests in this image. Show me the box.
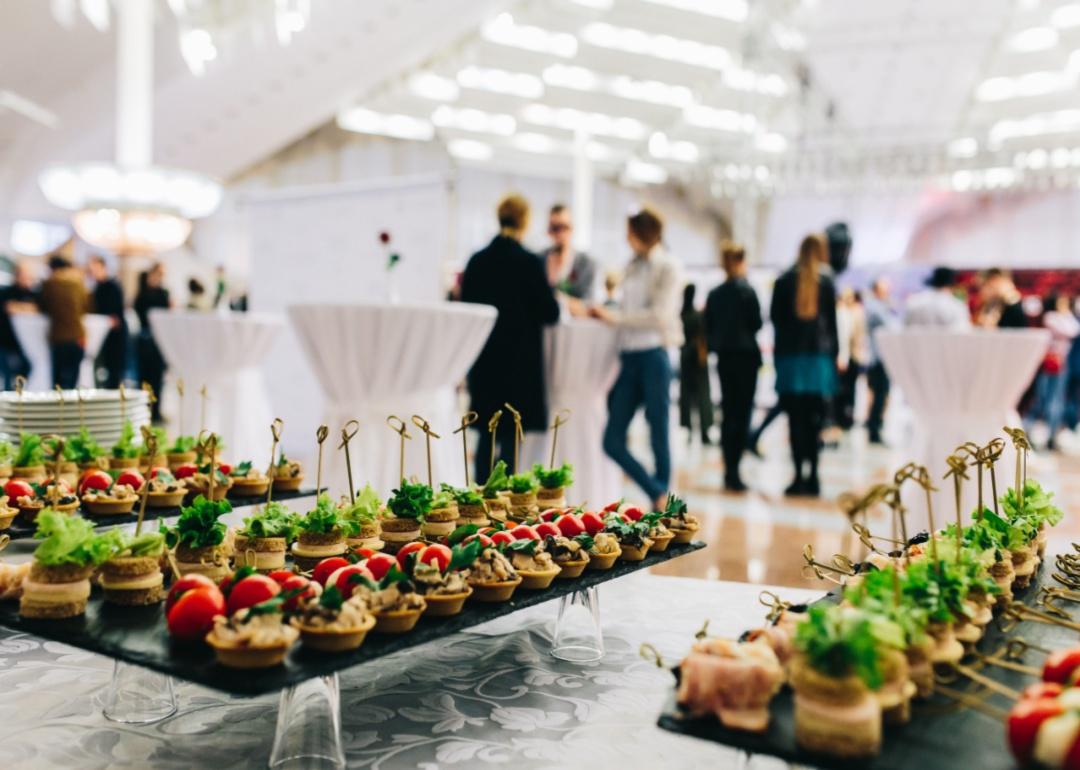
[643,419,1080,587]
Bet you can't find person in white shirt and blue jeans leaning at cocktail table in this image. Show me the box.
[591,208,683,510]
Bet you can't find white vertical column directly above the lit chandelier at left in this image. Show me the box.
[116,0,154,167]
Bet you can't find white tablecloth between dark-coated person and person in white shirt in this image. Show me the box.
[524,320,622,506]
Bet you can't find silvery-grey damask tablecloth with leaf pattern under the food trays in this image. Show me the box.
[0,575,816,770]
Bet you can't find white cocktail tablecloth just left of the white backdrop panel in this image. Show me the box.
[150,310,284,465]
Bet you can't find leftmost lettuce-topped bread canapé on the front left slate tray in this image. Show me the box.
[18,508,117,619]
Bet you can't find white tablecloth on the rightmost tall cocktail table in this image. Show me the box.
[876,329,1050,527]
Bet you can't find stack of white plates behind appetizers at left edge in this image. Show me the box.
[0,390,150,447]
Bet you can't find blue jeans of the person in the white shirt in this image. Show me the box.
[604,348,672,503]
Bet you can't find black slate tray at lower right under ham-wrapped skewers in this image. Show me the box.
[658,553,1062,770]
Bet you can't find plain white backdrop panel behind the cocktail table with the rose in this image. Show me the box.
[242,175,451,468]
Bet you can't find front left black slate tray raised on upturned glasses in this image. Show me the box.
[0,542,705,695]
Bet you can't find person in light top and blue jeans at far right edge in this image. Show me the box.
[1024,294,1080,450]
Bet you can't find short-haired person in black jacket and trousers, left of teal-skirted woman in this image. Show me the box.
[705,243,761,492]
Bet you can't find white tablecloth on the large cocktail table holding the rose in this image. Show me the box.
[288,302,497,495]
